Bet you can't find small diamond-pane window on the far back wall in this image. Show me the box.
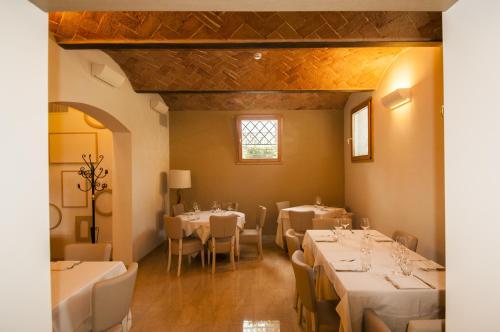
[237,115,281,162]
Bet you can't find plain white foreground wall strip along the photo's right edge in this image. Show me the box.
[443,0,500,331]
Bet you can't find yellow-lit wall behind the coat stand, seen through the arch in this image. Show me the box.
[49,107,113,260]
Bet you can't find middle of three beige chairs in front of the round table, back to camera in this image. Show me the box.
[207,214,238,273]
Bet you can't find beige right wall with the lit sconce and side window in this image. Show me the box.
[344,48,444,262]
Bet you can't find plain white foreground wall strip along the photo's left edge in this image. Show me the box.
[0,1,51,331]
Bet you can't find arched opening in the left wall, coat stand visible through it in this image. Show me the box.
[49,102,132,261]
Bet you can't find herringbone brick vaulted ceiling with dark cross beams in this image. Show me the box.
[49,12,442,110]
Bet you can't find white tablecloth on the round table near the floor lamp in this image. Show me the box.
[179,211,245,244]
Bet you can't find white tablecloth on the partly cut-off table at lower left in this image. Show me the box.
[51,262,127,332]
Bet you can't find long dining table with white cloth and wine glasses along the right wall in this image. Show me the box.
[303,230,446,332]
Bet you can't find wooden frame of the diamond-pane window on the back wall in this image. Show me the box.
[236,114,283,165]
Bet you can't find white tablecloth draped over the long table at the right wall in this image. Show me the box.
[303,230,445,332]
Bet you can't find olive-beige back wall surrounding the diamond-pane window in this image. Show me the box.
[170,110,344,233]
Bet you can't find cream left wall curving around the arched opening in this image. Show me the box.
[49,41,169,261]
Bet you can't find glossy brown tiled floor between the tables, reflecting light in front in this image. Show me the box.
[132,239,302,332]
